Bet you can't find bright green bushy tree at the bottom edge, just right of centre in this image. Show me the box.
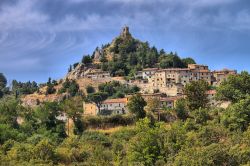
[128,118,166,166]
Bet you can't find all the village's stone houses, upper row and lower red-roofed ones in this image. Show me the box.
[83,64,237,115]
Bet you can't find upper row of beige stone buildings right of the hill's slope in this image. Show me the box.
[134,64,237,96]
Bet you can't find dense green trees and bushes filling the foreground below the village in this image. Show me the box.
[0,68,250,166]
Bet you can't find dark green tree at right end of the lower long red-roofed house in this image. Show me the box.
[127,94,147,119]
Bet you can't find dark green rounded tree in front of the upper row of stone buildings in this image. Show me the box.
[184,80,209,110]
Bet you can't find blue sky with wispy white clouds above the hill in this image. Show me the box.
[0,0,250,82]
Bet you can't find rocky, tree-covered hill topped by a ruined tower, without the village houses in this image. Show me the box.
[22,27,195,105]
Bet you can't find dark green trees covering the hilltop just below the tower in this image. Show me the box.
[85,35,195,77]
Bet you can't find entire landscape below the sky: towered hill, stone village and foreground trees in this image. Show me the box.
[0,27,250,166]
